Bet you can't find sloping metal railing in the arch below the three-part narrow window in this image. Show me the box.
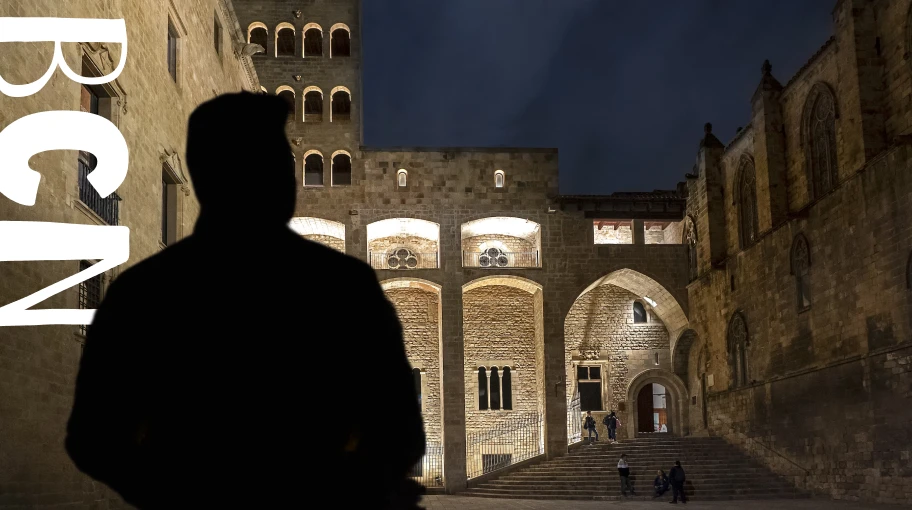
[466,413,545,479]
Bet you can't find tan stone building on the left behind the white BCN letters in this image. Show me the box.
[0,0,259,508]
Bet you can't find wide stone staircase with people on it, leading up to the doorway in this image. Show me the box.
[462,437,810,501]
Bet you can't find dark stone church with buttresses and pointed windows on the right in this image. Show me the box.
[672,0,912,504]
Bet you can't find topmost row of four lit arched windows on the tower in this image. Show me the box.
[247,21,351,58]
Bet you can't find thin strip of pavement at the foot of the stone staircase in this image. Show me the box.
[423,496,900,510]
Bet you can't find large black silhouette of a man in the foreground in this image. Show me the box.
[66,93,425,509]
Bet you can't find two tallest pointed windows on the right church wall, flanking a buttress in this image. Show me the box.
[734,83,839,249]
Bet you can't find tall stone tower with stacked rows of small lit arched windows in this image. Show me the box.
[235,0,362,193]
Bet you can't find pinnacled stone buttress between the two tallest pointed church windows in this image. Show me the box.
[751,60,788,232]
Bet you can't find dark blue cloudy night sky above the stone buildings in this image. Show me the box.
[362,0,835,194]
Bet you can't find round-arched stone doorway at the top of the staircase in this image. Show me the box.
[626,369,690,437]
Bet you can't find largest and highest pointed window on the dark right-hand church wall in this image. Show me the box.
[803,83,839,198]
